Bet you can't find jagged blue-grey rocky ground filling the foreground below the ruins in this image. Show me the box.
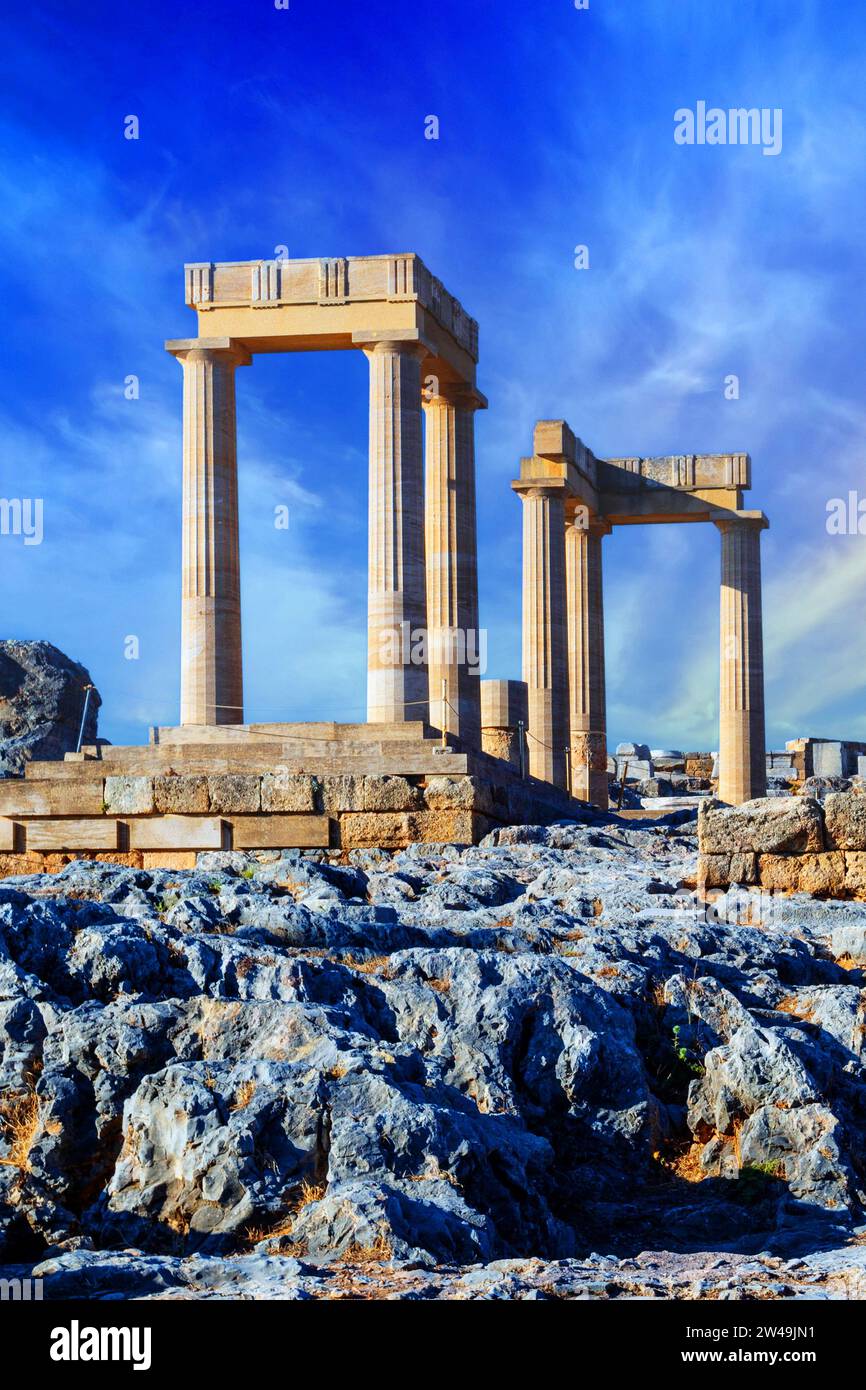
[0,816,866,1300]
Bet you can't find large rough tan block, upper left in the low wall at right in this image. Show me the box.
[698,796,824,855]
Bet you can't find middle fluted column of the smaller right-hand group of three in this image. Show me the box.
[566,509,610,810]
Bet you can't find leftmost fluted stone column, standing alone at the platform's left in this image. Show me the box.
[167,338,250,724]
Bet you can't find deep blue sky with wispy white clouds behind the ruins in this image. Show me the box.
[0,0,866,748]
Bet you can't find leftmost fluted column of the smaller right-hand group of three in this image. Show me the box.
[513,478,569,787]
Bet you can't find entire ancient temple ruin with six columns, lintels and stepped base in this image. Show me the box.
[0,256,767,873]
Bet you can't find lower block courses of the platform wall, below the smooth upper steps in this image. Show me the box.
[0,763,578,877]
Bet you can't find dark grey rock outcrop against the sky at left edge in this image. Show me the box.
[0,641,101,777]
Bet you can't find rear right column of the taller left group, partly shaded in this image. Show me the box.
[424,384,484,748]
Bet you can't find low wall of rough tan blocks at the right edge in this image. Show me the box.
[698,792,866,899]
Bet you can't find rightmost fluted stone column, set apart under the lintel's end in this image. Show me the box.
[716,513,767,805]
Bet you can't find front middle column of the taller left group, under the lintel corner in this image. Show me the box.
[364,342,428,724]
